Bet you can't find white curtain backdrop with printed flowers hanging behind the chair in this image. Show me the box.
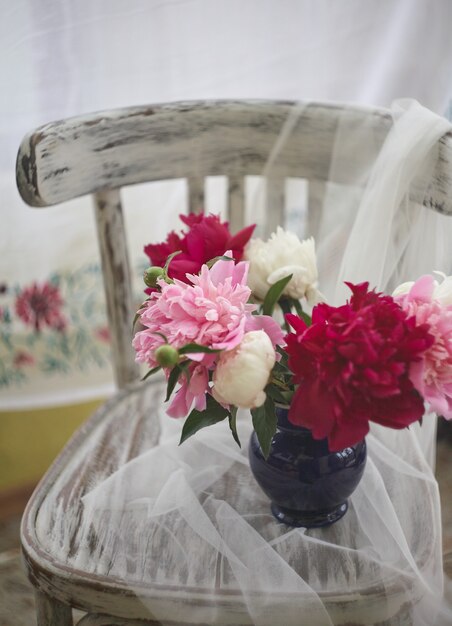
[0,0,452,409]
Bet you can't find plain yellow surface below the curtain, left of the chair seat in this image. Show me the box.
[0,400,101,491]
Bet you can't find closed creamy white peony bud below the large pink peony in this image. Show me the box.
[212,330,275,409]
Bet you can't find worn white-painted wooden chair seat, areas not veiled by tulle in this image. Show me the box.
[22,381,433,625]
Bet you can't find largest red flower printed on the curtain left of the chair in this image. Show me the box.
[15,283,67,332]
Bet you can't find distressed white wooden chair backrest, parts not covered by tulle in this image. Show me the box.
[17,101,452,387]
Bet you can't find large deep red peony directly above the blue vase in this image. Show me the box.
[285,283,433,451]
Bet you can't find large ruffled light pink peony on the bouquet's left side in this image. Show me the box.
[133,251,283,417]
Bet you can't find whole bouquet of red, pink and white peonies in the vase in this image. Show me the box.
[133,215,452,456]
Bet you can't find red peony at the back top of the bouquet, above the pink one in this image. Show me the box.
[144,213,256,283]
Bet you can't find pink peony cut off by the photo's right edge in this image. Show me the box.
[395,275,452,419]
